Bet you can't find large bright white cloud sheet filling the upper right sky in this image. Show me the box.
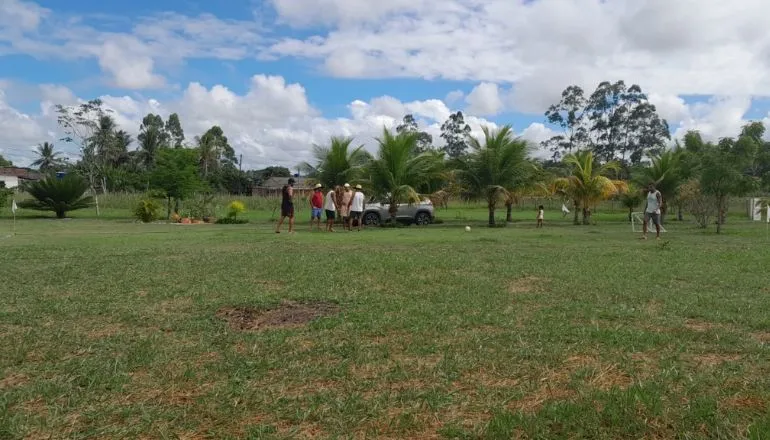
[271,0,770,113]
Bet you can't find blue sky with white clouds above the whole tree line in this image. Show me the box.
[0,0,770,166]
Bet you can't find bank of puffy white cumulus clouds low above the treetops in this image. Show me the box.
[0,75,770,168]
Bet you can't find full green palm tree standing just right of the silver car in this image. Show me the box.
[461,125,531,226]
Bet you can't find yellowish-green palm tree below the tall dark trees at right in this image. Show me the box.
[557,150,626,225]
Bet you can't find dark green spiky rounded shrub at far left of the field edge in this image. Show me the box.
[19,174,94,218]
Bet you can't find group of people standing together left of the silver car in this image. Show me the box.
[275,178,365,234]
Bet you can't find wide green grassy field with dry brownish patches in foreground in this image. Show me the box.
[0,208,770,439]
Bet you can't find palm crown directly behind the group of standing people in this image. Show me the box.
[300,136,372,188]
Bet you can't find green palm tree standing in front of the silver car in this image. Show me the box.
[368,129,443,221]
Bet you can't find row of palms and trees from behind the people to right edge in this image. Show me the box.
[304,122,770,232]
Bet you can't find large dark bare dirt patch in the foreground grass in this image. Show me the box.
[216,301,340,331]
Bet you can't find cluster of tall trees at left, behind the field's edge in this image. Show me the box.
[23,99,290,213]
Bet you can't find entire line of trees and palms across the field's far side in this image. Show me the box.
[16,81,770,231]
